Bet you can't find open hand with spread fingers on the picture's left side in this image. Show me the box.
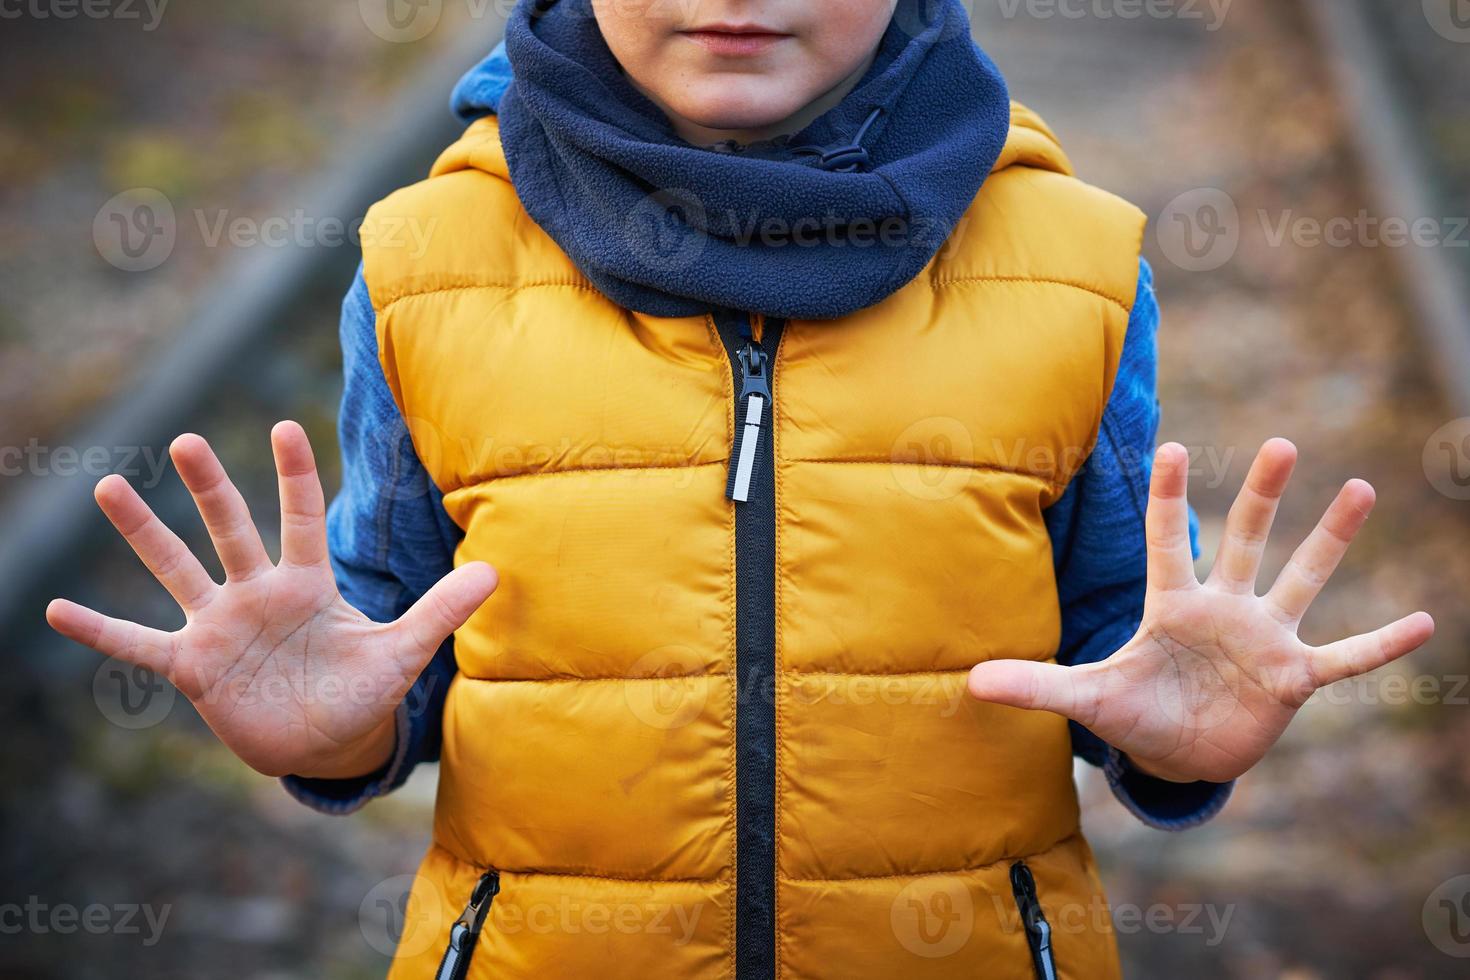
[46,422,497,779]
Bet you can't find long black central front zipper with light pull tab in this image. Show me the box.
[713,309,785,980]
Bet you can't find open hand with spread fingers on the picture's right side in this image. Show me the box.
[969,439,1435,782]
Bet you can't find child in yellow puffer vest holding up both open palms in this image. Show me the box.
[47,0,1433,980]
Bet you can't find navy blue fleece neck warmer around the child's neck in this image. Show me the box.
[500,0,1010,319]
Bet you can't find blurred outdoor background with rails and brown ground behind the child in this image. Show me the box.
[0,0,1470,980]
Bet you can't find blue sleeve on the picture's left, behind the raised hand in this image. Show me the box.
[282,267,463,814]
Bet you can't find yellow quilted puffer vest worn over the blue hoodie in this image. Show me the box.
[365,106,1144,980]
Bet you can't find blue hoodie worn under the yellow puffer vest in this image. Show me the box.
[284,44,1235,830]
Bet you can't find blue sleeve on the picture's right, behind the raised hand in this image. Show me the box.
[1047,262,1235,830]
